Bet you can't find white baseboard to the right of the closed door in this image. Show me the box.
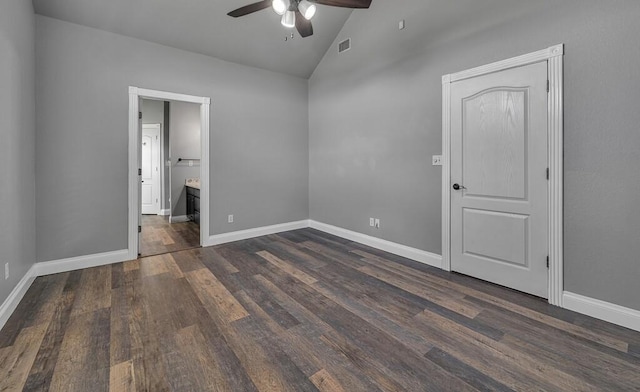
[562,291,640,331]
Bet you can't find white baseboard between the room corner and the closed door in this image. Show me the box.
[309,220,442,268]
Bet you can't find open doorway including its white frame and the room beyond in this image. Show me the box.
[128,87,210,259]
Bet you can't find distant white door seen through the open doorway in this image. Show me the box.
[140,124,161,215]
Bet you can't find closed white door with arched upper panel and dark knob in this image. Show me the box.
[450,62,548,298]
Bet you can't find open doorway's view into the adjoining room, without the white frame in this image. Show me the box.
[139,99,201,257]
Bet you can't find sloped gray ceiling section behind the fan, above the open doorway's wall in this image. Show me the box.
[33,0,352,78]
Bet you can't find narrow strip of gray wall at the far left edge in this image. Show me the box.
[0,0,36,304]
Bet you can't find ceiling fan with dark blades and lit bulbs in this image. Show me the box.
[227,0,371,37]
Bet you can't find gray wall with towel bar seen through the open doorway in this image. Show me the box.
[169,101,201,216]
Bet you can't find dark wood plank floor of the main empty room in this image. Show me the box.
[0,229,640,392]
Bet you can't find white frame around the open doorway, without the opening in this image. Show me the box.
[128,86,211,260]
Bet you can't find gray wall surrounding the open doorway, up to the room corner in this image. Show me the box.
[36,16,309,261]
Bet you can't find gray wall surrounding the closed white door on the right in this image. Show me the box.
[309,0,640,309]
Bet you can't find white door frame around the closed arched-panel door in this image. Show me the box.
[442,44,564,307]
